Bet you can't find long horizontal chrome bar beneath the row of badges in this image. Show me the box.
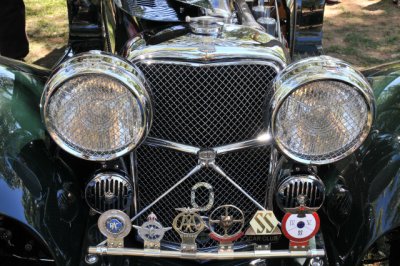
[89,247,325,260]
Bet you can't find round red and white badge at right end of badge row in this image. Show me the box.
[282,212,320,242]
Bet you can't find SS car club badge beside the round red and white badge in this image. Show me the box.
[245,210,282,243]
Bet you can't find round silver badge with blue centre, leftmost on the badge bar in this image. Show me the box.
[97,210,132,248]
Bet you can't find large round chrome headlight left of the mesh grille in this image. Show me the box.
[42,52,152,161]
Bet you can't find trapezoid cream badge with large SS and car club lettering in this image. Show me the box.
[246,210,281,236]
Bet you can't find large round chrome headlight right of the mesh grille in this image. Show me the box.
[271,56,375,164]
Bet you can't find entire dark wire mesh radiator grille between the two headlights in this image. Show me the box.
[137,63,276,248]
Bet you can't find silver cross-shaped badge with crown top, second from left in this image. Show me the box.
[133,213,171,250]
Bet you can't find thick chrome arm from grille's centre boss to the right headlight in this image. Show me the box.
[212,132,272,155]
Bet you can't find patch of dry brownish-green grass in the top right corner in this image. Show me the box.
[323,0,400,67]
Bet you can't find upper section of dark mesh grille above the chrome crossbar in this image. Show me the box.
[138,62,276,148]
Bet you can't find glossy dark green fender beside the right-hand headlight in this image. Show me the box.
[321,62,400,265]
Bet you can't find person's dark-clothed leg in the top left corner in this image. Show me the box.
[0,0,29,59]
